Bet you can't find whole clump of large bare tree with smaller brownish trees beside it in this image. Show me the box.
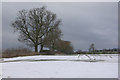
[12,6,73,52]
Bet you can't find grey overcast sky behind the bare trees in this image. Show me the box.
[2,2,118,50]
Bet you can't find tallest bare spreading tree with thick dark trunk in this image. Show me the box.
[12,6,61,52]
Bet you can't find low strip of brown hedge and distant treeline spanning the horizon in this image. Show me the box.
[0,48,118,58]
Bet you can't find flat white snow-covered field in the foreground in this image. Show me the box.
[0,54,118,78]
